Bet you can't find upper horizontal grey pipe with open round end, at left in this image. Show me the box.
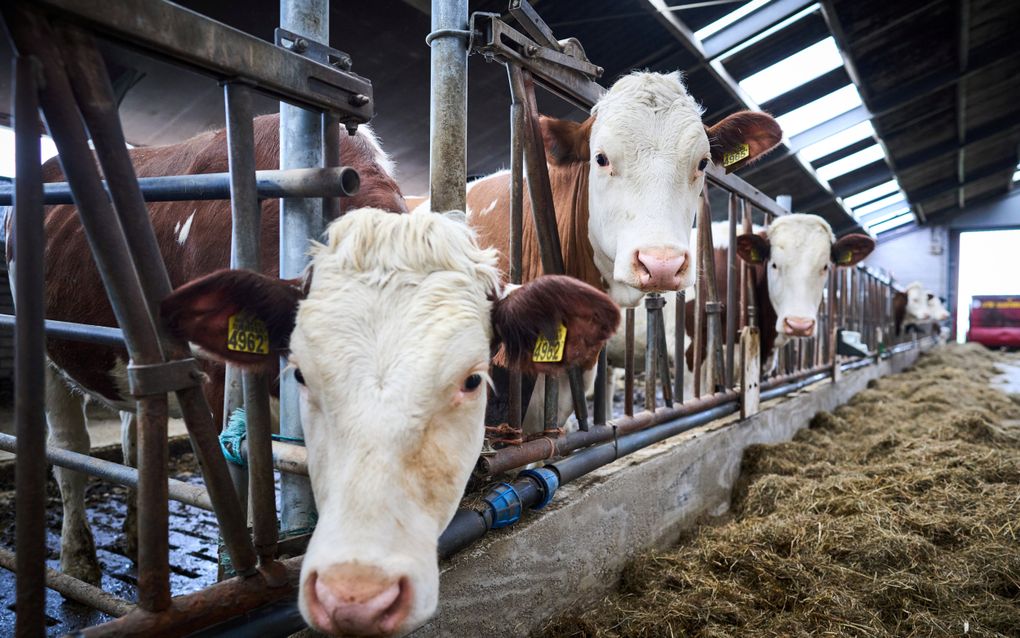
[0,166,361,206]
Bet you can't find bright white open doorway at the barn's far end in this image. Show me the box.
[956,229,1020,343]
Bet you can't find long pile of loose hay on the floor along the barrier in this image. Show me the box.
[544,345,1020,638]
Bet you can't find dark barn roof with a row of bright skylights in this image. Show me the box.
[0,0,1020,238]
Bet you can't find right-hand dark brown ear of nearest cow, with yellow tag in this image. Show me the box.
[493,275,620,375]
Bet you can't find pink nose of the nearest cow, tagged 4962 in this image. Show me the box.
[304,563,412,636]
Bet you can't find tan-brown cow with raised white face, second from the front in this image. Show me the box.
[419,71,782,431]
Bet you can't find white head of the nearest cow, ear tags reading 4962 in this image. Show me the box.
[161,209,619,636]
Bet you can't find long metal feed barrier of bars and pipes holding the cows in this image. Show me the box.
[0,0,930,636]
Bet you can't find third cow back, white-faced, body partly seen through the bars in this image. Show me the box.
[607,213,875,395]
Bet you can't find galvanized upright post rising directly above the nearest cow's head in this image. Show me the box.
[428,0,467,211]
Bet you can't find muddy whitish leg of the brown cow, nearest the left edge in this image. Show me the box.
[46,366,101,585]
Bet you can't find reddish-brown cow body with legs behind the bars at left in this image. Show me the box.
[6,114,407,584]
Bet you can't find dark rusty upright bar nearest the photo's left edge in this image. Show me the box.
[11,54,46,638]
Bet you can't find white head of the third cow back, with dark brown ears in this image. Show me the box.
[736,214,875,346]
